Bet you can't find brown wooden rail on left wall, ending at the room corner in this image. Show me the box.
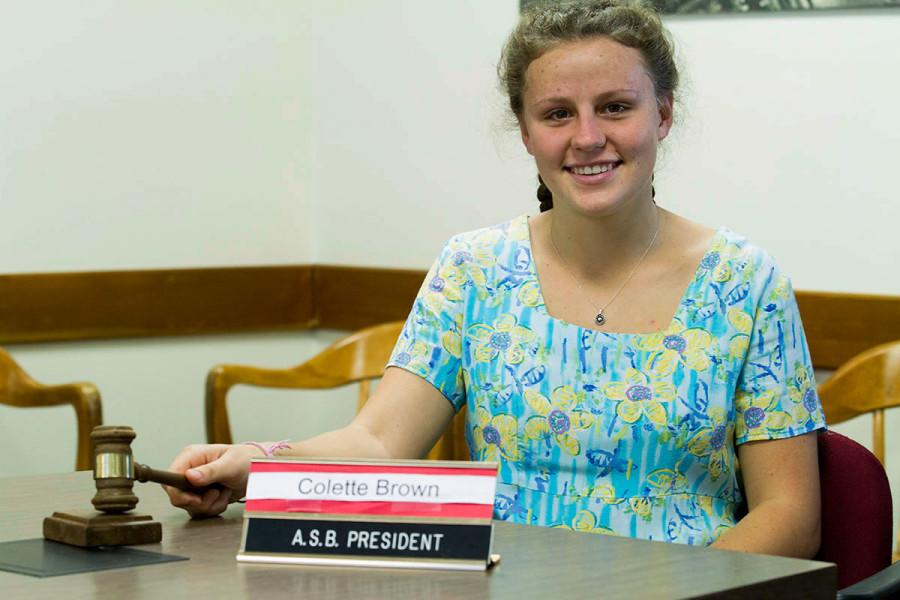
[0,265,315,344]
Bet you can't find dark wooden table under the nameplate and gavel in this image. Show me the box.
[0,472,836,600]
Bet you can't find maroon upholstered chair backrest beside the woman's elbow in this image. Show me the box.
[815,431,893,588]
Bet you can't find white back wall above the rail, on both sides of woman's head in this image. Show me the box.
[312,0,900,294]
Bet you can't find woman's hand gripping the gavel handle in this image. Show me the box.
[163,444,263,518]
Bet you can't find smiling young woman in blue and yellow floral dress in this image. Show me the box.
[169,0,824,557]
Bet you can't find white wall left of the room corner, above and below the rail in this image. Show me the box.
[0,0,342,476]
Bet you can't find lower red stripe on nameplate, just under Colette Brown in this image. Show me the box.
[244,499,494,519]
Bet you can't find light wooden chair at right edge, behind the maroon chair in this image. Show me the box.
[819,341,900,561]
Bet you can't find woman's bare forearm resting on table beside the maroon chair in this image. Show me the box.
[712,499,820,558]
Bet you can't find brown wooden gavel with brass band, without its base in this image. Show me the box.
[91,425,217,514]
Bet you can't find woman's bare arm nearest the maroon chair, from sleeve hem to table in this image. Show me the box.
[712,432,821,558]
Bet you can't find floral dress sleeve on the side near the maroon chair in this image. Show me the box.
[734,261,825,444]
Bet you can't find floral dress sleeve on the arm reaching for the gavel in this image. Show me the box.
[387,244,466,410]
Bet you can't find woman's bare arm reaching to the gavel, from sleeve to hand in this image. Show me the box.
[166,368,454,517]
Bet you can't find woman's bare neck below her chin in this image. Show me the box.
[546,200,664,279]
